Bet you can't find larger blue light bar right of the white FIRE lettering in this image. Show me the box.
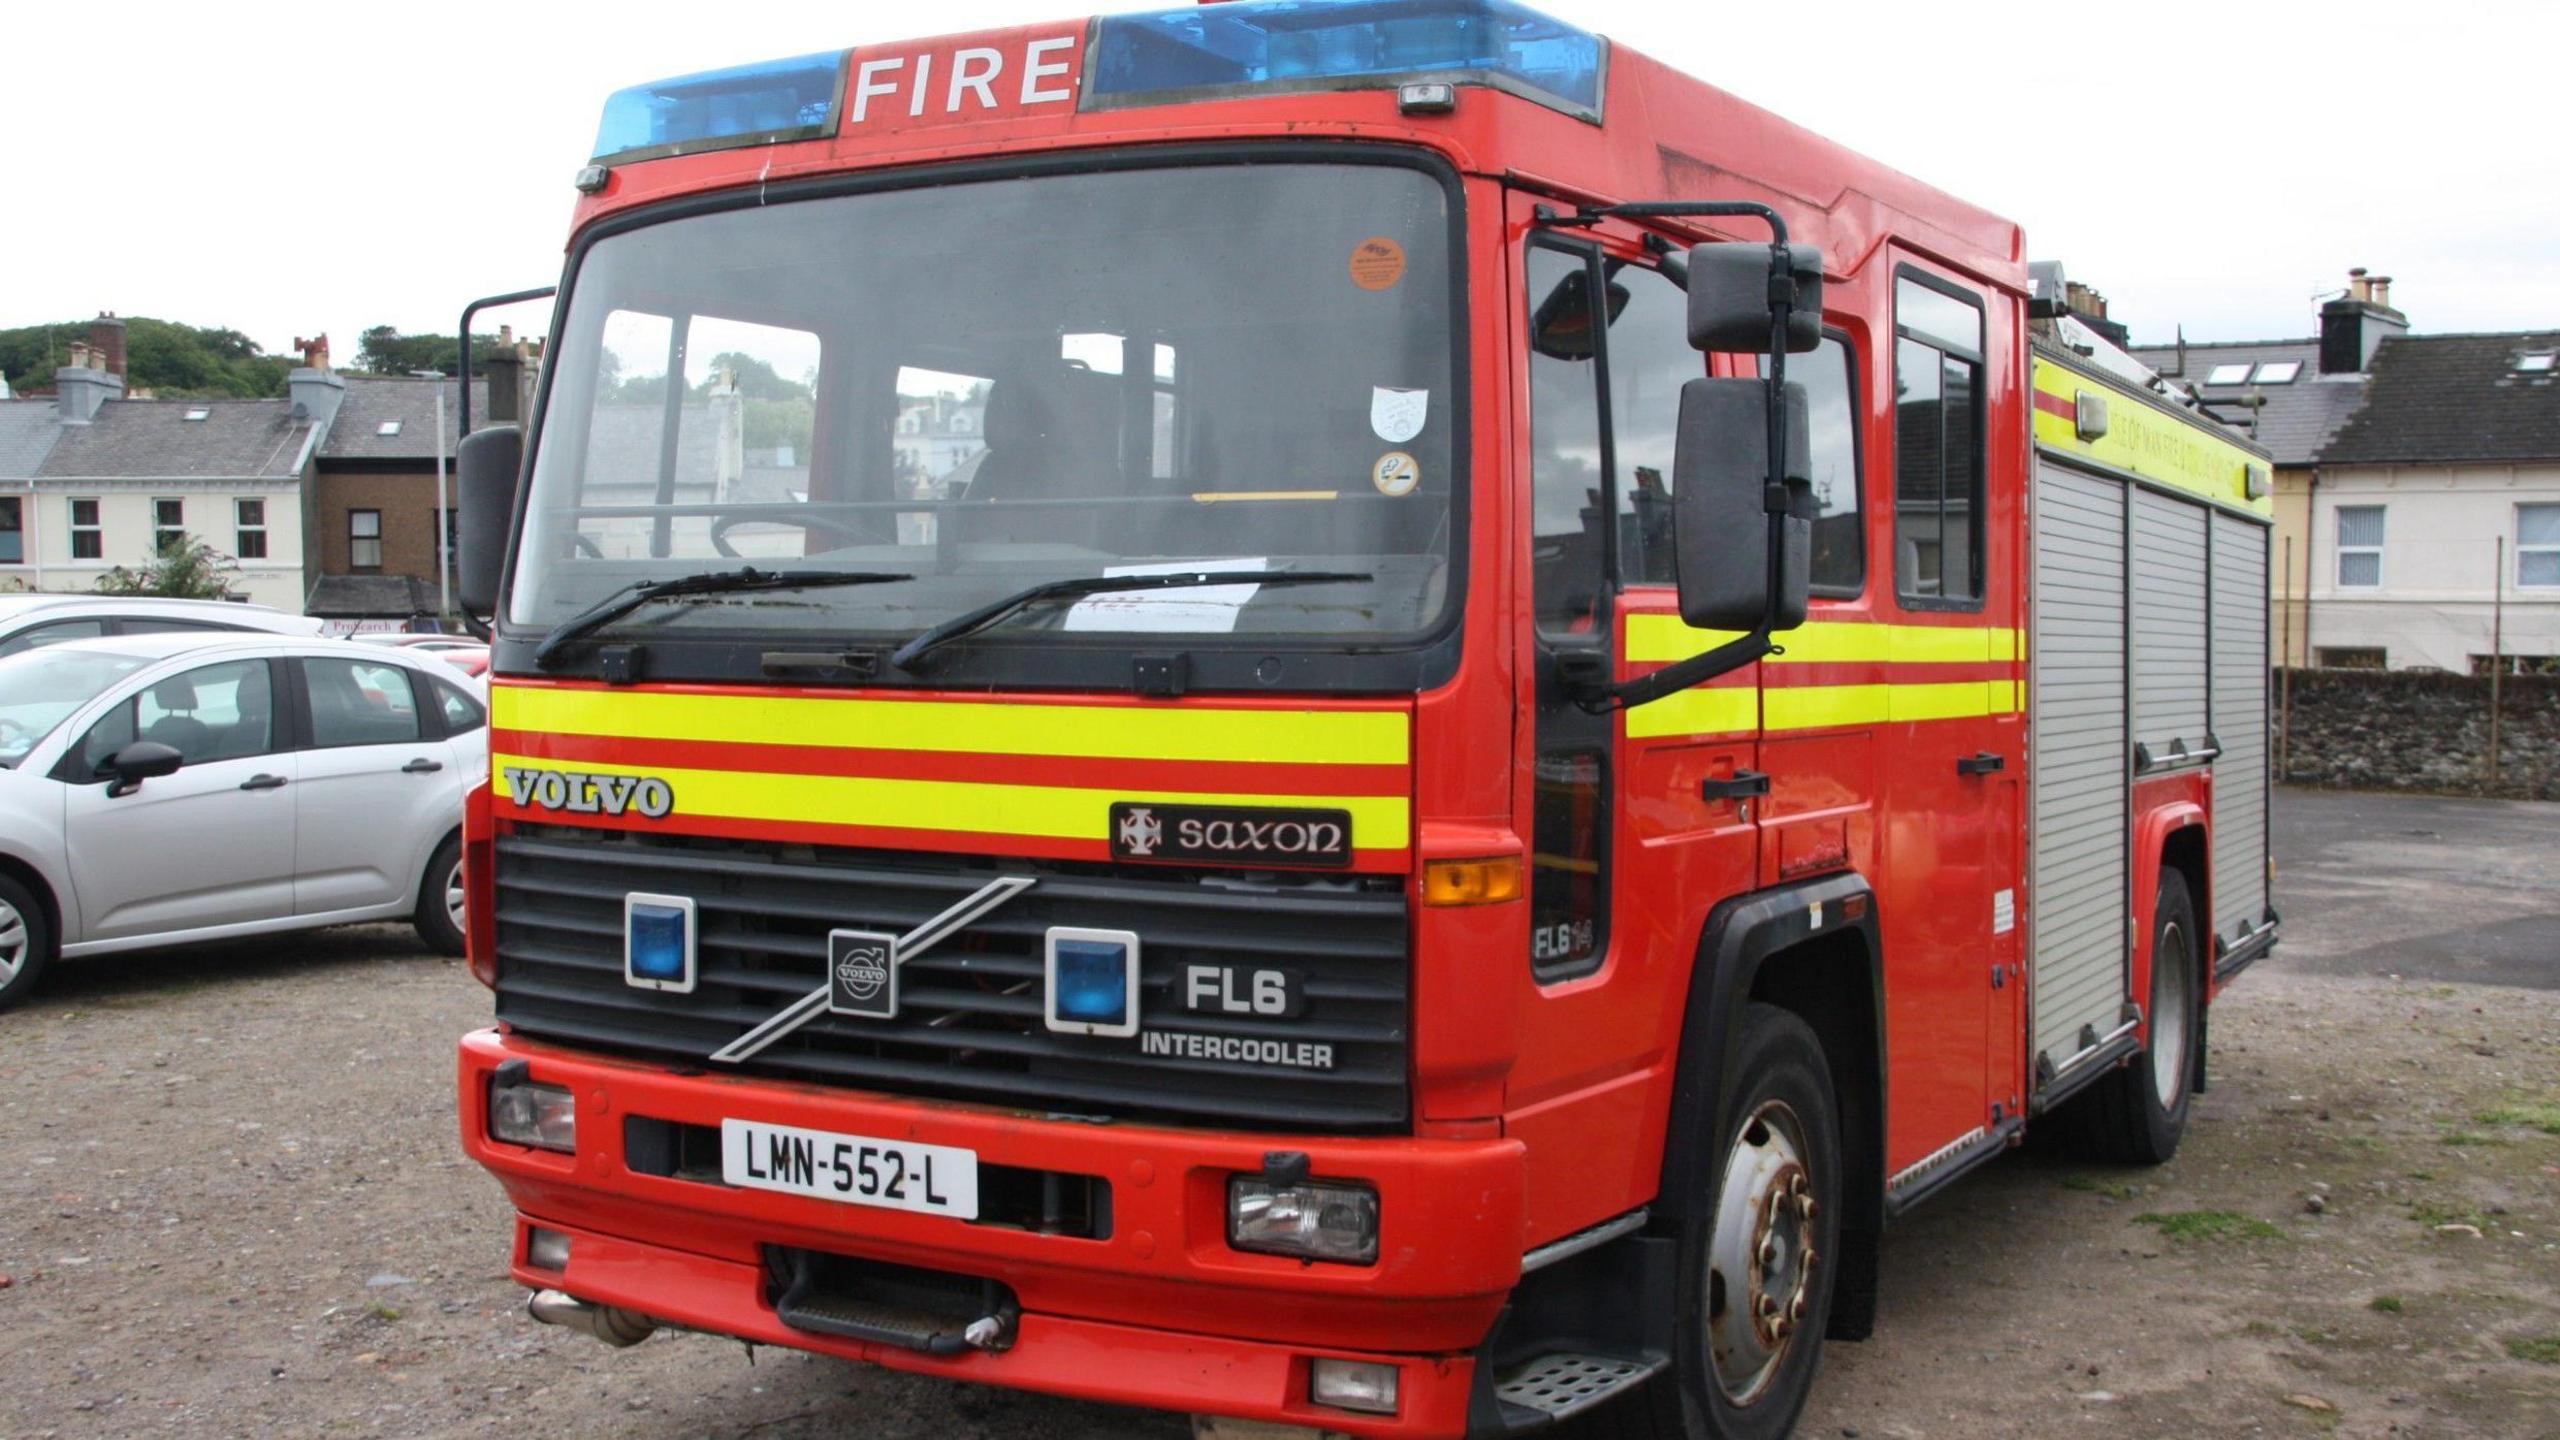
[1085,0,1608,120]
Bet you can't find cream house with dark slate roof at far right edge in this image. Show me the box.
[2304,331,2560,674]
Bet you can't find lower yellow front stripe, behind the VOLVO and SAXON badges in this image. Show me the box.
[489,756,1413,851]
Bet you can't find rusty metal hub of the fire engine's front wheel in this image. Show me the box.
[1708,1102,1823,1404]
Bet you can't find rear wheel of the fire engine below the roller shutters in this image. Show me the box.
[2053,869,2204,1166]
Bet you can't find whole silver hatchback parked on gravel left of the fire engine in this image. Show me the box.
[0,630,489,1010]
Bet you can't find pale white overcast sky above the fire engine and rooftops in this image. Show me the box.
[0,0,2560,376]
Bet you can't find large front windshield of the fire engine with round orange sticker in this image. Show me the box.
[507,164,1462,661]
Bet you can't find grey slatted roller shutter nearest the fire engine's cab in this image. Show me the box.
[2028,464,2130,1066]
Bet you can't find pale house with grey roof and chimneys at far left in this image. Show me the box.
[0,315,320,612]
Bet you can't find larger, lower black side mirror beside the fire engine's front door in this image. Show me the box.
[1672,379,1812,630]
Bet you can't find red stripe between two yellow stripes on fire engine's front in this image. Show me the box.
[489,730,1413,797]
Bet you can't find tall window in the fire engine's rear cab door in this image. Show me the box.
[1894,272,1984,610]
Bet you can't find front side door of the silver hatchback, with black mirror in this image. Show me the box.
[54,659,297,943]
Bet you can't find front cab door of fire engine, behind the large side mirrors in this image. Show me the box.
[1505,195,1759,1235]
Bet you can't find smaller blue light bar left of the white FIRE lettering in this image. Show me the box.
[596,51,845,161]
